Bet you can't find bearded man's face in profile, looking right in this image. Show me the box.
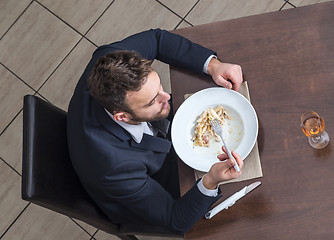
[126,71,170,124]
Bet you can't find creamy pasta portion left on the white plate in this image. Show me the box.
[192,105,230,147]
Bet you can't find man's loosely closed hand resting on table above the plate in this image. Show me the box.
[207,58,243,91]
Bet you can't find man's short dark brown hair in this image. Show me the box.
[88,51,153,113]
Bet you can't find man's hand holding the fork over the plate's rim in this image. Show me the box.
[203,147,244,189]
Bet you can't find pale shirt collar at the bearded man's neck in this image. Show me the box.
[104,109,153,143]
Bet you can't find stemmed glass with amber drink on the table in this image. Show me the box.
[300,112,329,149]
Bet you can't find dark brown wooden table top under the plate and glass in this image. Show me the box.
[171,2,334,240]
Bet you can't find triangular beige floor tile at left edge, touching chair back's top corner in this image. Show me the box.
[0,65,34,133]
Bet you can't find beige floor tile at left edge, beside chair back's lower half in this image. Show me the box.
[0,159,28,236]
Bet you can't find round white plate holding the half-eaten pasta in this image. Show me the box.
[172,87,258,172]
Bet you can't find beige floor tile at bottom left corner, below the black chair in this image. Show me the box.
[2,204,90,240]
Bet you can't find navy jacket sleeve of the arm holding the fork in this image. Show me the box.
[101,159,219,233]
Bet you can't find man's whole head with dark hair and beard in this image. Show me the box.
[88,51,170,124]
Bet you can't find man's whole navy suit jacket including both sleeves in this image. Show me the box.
[67,29,218,233]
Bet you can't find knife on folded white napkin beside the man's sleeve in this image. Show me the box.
[204,181,261,219]
